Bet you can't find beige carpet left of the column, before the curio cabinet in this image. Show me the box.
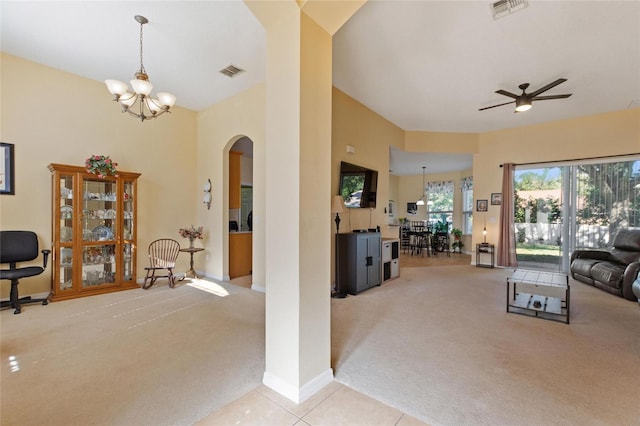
[0,281,264,426]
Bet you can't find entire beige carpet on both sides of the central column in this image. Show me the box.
[0,266,640,426]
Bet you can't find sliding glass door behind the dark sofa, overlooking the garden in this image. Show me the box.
[514,158,640,272]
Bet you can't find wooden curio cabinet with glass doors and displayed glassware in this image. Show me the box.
[49,164,140,301]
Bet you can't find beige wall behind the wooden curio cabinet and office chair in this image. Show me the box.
[0,53,201,298]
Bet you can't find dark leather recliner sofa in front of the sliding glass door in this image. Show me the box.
[571,229,640,301]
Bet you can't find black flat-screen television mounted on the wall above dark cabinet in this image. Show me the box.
[339,161,378,209]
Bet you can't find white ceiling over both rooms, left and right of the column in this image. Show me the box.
[0,0,640,174]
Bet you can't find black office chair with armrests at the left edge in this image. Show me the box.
[0,231,51,314]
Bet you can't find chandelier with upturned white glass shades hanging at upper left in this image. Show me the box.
[105,15,176,121]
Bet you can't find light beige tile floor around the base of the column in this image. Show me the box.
[197,381,426,426]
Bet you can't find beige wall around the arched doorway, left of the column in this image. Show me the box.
[195,84,266,290]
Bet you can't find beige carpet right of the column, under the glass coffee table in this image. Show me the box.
[332,266,640,425]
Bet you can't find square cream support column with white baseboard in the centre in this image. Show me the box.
[246,1,362,403]
